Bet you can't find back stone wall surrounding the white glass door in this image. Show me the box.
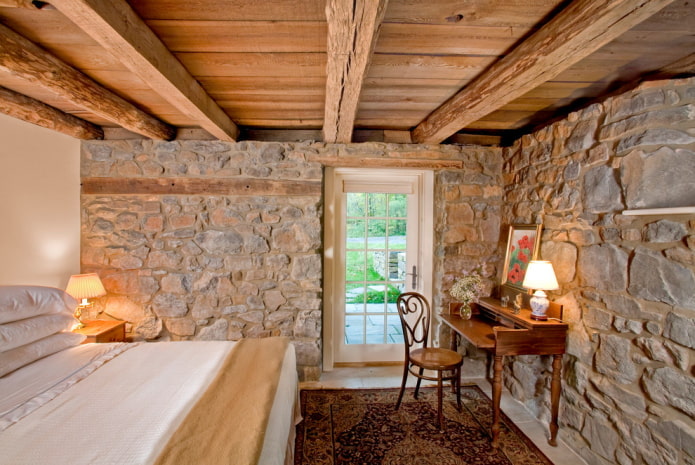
[81,140,503,379]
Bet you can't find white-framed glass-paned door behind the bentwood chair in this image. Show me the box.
[327,169,432,363]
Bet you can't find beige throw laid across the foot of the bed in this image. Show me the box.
[155,337,289,465]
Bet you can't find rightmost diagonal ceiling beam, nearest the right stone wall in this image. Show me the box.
[412,0,673,144]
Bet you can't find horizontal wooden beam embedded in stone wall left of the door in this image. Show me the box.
[82,178,323,196]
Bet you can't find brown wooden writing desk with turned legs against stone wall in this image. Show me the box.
[440,297,567,447]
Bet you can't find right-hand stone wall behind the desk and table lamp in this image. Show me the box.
[502,79,695,465]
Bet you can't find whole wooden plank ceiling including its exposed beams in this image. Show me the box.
[0,0,695,144]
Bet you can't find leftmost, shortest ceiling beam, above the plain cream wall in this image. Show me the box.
[0,87,104,139]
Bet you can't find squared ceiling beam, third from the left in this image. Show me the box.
[51,0,239,141]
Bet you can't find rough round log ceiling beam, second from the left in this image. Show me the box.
[0,25,176,140]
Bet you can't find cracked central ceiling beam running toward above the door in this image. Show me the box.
[323,0,388,143]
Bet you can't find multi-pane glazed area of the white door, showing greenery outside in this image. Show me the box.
[345,193,407,344]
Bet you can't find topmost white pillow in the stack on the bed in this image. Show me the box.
[0,286,77,324]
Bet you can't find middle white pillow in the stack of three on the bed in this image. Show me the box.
[0,313,77,352]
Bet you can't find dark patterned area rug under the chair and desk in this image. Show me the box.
[295,385,552,465]
